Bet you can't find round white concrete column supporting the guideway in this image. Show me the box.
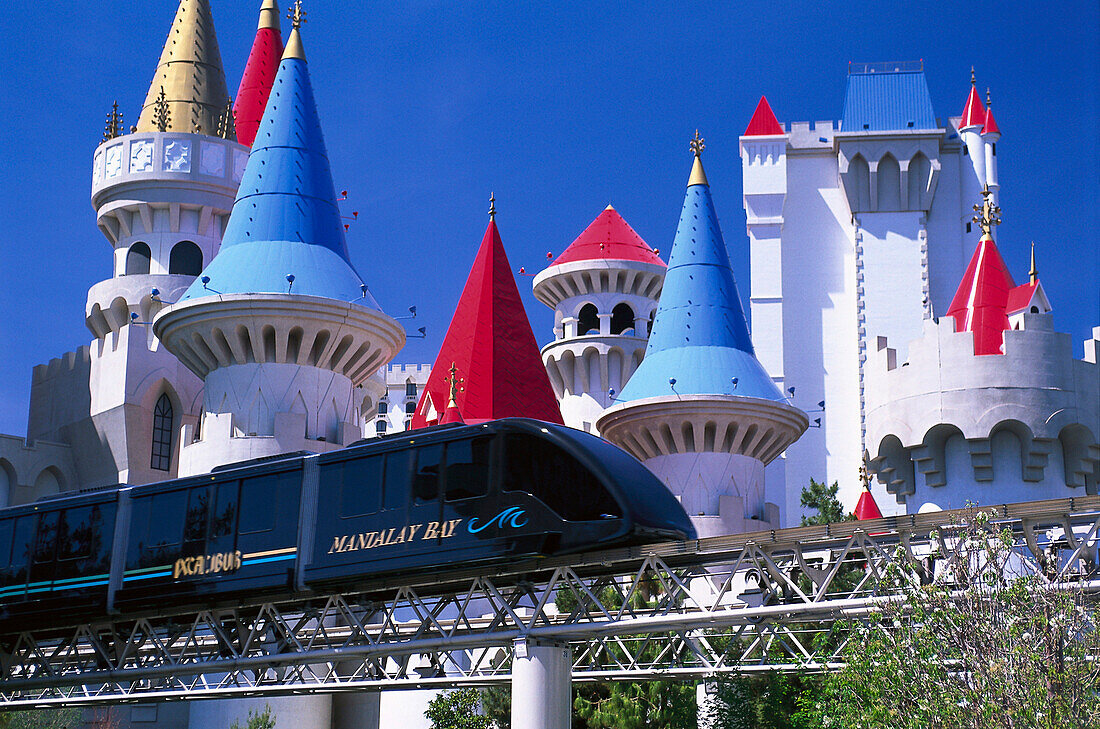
[512,640,573,729]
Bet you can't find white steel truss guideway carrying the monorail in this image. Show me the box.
[0,497,1100,709]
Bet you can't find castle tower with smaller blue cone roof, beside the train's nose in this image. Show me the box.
[596,134,807,537]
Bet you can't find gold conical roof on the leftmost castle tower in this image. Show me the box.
[138,0,229,136]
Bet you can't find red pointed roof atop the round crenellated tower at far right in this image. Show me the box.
[947,235,1015,354]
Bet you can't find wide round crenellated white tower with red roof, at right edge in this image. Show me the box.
[868,189,1100,513]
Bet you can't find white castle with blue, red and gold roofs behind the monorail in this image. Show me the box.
[0,0,1100,729]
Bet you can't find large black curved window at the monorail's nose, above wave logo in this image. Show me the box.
[504,433,622,521]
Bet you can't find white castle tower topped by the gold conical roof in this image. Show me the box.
[38,0,248,486]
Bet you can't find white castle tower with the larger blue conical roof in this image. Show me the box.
[154,7,405,475]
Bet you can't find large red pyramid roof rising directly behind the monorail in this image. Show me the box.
[413,221,562,428]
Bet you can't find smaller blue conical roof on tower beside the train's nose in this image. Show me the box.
[618,157,784,401]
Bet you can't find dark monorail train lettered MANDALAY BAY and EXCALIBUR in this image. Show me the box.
[0,418,695,634]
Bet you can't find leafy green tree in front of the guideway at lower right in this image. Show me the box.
[803,512,1100,729]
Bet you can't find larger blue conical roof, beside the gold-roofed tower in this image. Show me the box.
[183,29,377,308]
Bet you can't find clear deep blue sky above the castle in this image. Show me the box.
[0,0,1100,434]
